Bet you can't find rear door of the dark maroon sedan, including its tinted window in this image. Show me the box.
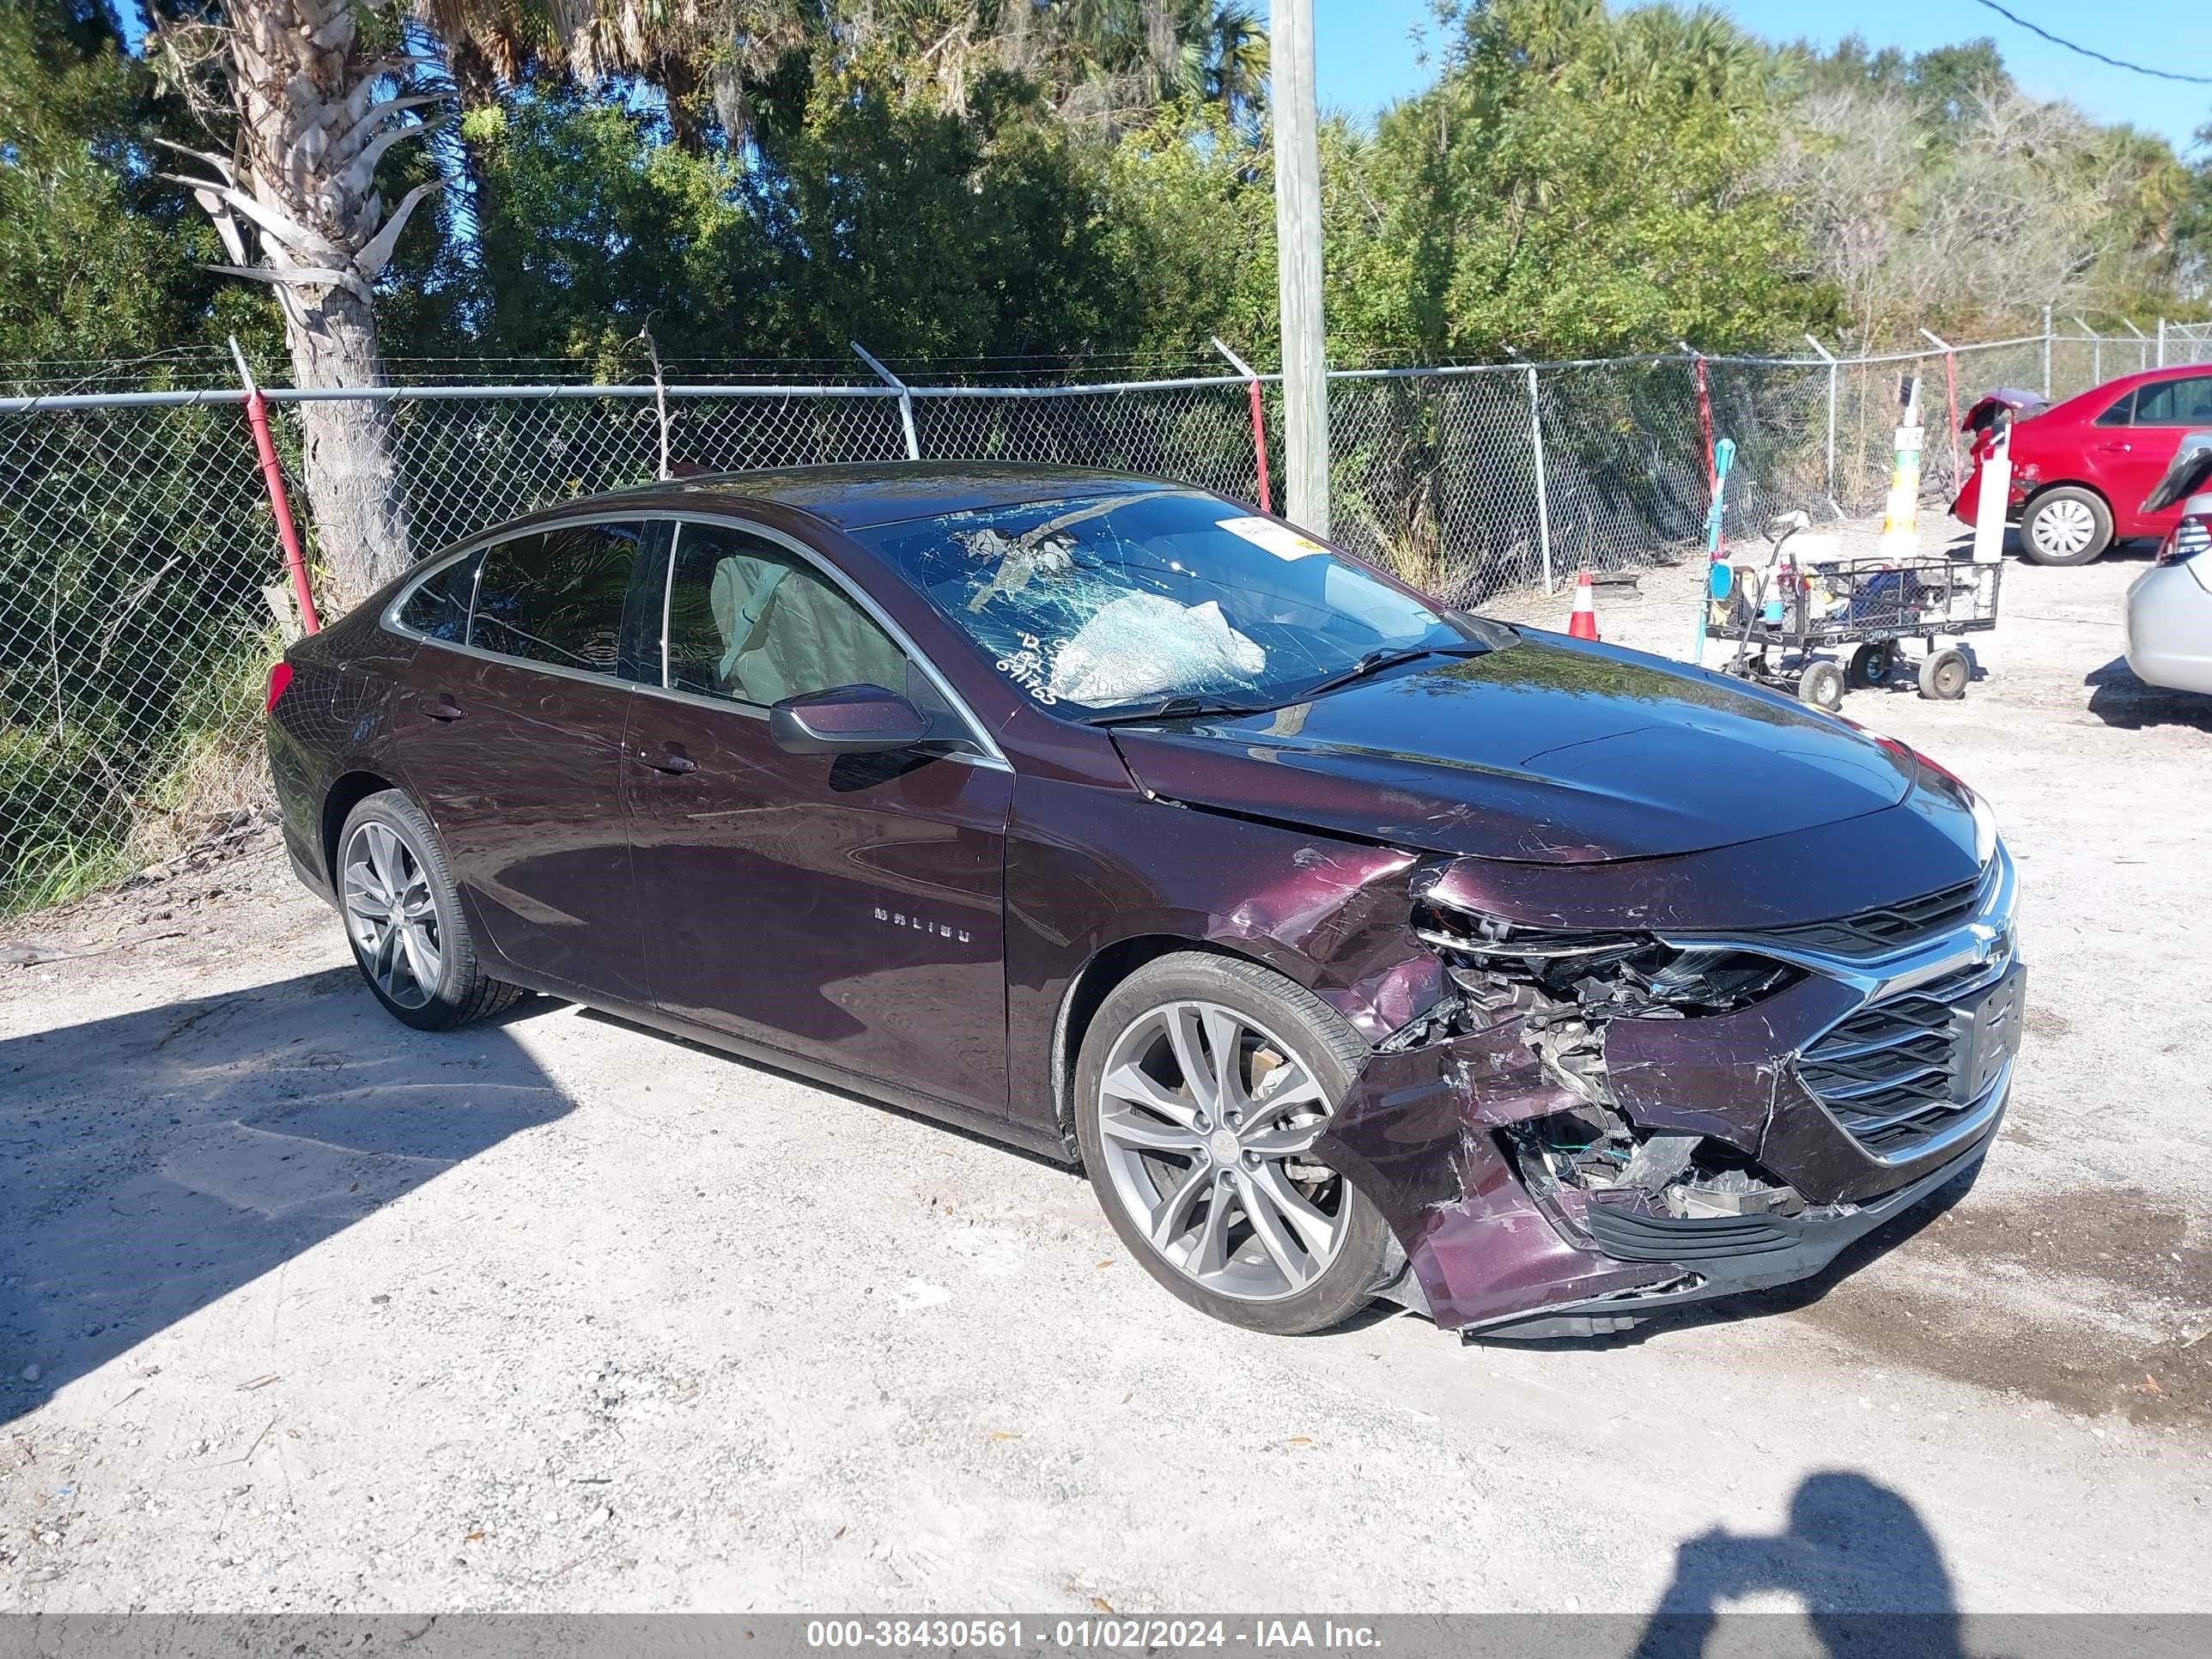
[389,520,661,1006]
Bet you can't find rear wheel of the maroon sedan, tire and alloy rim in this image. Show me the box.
[334,790,522,1030]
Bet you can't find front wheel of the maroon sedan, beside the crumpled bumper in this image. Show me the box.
[1075,951,1387,1336]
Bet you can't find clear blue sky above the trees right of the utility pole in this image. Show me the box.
[1314,0,2212,149]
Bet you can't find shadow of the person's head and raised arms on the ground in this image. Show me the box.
[1632,1471,1964,1659]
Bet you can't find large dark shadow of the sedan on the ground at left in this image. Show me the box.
[0,967,571,1422]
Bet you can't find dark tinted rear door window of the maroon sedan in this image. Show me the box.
[469,525,644,675]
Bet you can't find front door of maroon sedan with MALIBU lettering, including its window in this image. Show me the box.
[623,520,1013,1115]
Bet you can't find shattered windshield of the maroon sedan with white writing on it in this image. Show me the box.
[856,489,1467,719]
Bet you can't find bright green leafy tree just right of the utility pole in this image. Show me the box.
[1364,0,1832,358]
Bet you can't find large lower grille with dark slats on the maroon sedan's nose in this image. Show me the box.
[1798,957,2011,1159]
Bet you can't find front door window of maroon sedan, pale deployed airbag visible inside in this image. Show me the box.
[668,525,907,708]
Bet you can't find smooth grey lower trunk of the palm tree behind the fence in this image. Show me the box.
[285,288,414,611]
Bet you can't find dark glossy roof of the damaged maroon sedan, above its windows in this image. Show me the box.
[533,460,1188,531]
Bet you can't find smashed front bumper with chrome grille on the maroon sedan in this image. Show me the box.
[1316,848,2024,1336]
